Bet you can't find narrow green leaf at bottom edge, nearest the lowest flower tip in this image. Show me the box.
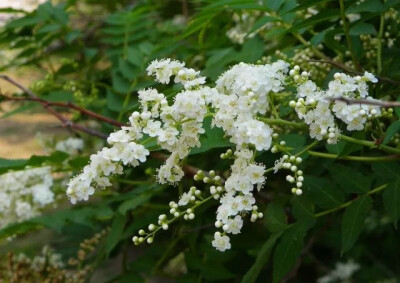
[242,233,282,283]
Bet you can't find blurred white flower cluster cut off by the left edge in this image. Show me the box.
[0,167,54,228]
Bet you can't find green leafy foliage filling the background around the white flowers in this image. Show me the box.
[0,0,400,282]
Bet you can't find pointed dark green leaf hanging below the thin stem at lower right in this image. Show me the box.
[342,195,372,254]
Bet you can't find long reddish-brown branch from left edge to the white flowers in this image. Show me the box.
[0,93,125,127]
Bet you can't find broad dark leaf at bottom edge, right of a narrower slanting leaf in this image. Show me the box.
[273,218,316,282]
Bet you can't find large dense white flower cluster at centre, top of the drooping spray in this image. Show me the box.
[211,60,289,151]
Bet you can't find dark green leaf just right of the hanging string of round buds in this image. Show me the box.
[304,176,344,208]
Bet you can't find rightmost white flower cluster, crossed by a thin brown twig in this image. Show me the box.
[290,66,381,144]
